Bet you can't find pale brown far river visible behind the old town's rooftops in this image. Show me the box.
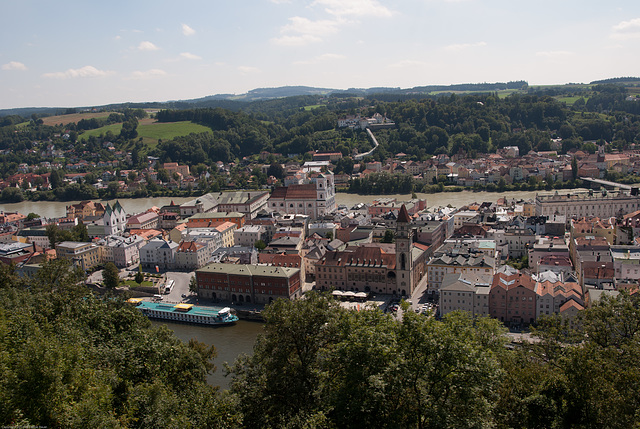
[0,191,552,218]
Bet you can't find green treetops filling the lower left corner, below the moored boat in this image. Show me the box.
[0,262,241,428]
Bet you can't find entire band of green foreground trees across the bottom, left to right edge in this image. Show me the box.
[0,261,640,428]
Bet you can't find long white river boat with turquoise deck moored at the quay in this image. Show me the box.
[129,298,238,326]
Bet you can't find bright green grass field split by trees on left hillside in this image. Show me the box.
[80,118,211,146]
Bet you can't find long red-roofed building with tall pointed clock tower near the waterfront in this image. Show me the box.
[315,205,427,296]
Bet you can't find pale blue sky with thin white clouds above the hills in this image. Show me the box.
[0,0,640,109]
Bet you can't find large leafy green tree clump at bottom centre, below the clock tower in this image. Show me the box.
[230,294,505,428]
